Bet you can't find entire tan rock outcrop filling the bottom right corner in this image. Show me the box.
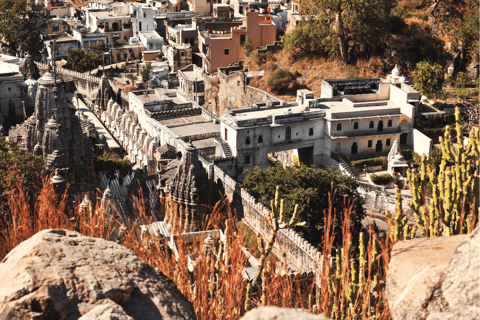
[386,228,480,320]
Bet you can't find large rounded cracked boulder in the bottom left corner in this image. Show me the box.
[0,230,196,320]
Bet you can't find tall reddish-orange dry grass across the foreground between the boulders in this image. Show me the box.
[0,169,398,319]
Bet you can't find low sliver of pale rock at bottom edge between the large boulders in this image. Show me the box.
[241,307,328,320]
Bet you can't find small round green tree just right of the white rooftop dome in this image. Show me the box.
[413,61,444,97]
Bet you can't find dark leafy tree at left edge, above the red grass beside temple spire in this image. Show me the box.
[0,137,45,216]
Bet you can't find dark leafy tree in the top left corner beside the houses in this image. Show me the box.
[0,0,46,55]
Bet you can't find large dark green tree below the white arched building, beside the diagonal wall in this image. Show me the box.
[241,164,364,247]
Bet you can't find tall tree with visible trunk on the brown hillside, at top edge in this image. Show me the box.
[301,0,394,64]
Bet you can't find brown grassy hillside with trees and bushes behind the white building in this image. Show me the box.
[246,0,479,103]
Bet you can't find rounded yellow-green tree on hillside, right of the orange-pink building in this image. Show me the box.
[283,19,339,56]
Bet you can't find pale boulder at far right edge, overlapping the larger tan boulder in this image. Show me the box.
[442,227,480,320]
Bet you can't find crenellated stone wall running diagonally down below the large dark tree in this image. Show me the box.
[201,159,322,273]
